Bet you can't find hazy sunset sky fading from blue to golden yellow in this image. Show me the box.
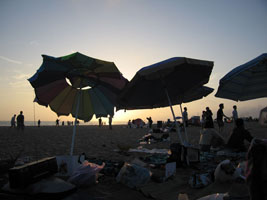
[0,0,267,123]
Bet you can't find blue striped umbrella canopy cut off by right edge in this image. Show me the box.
[215,53,267,101]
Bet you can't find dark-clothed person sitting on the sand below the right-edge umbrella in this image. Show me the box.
[227,118,253,151]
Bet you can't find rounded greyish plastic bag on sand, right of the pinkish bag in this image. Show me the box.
[116,163,151,188]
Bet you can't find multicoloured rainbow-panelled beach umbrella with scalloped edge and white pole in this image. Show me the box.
[28,52,128,155]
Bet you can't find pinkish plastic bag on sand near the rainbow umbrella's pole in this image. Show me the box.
[68,160,105,187]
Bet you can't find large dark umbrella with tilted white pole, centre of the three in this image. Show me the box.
[117,57,213,143]
